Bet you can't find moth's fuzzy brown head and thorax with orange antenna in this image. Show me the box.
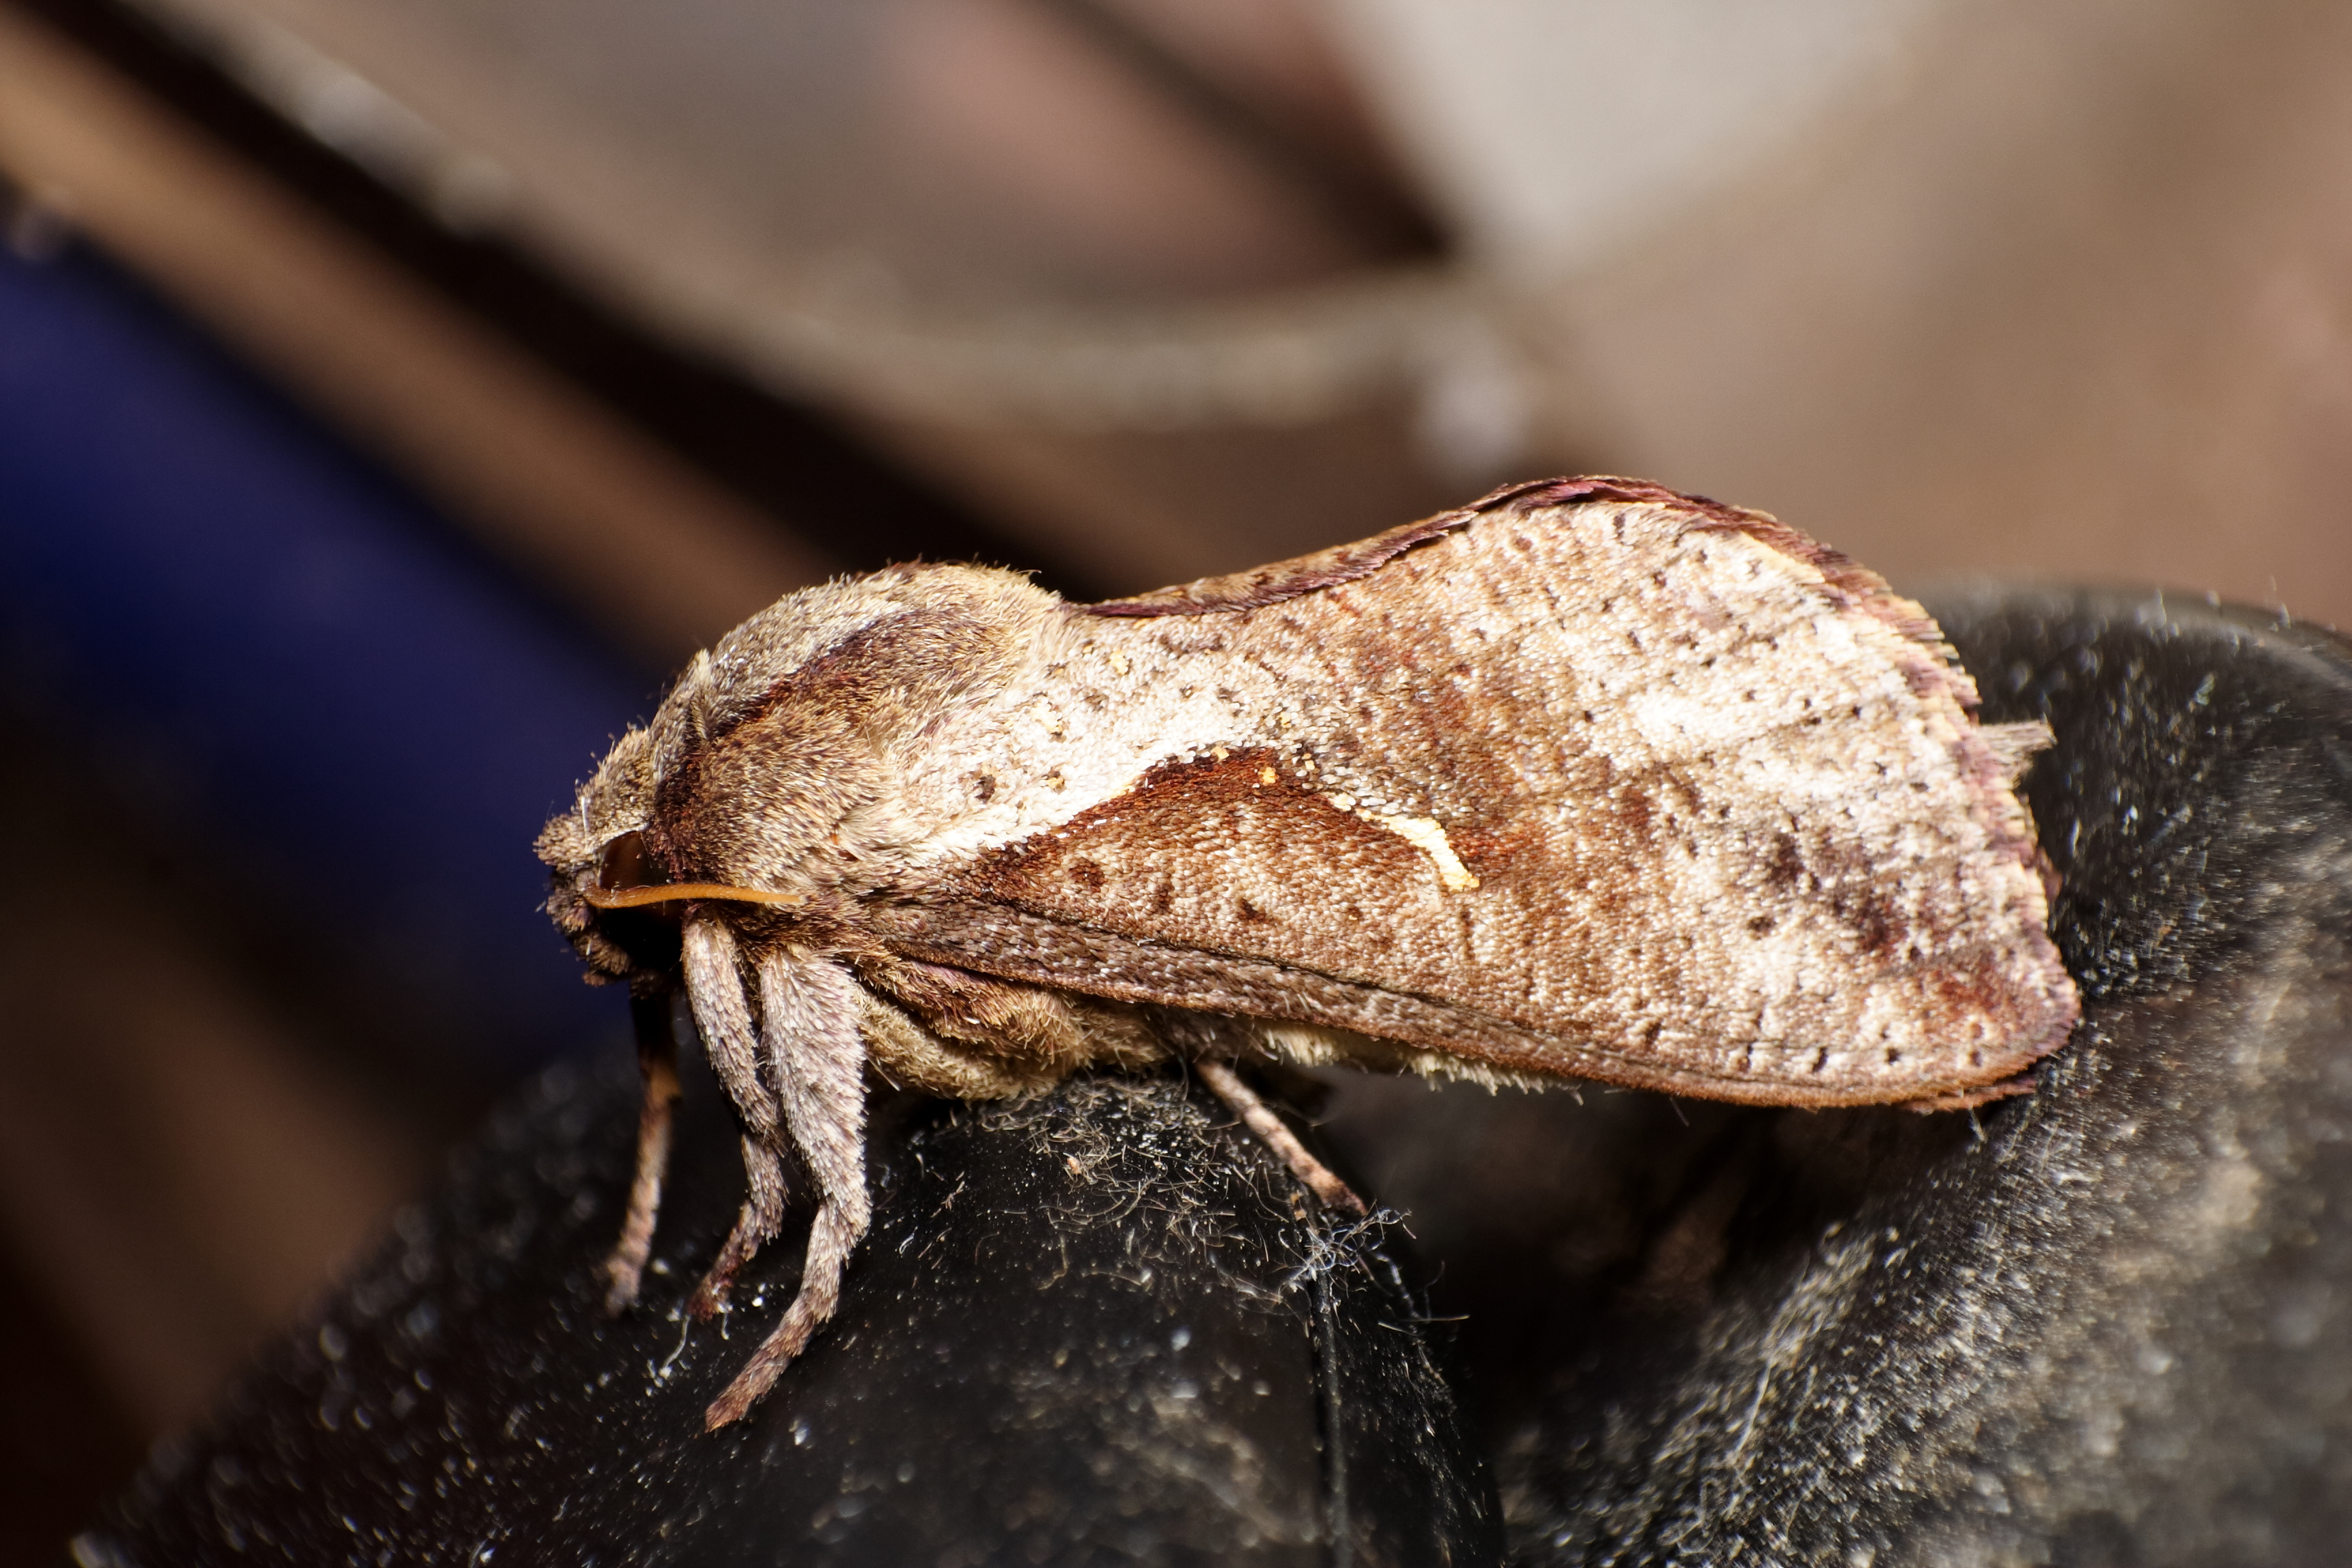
[538,566,1056,992]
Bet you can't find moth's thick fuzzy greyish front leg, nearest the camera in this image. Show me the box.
[703,943,868,1427]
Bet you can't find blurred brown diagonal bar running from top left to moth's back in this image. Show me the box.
[0,5,830,661]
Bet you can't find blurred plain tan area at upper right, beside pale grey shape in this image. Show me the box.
[1529,0,2352,623]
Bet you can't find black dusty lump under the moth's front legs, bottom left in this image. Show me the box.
[91,1062,1501,1568]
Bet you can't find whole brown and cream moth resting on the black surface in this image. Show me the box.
[538,480,2077,1424]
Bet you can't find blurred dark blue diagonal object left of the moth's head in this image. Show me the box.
[0,232,659,1075]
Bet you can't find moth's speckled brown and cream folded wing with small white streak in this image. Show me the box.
[889,480,2077,1105]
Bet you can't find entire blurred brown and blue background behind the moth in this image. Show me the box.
[0,0,2352,1561]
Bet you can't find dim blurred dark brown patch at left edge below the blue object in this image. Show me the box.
[0,879,426,1437]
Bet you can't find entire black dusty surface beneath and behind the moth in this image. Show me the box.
[69,595,2352,1568]
